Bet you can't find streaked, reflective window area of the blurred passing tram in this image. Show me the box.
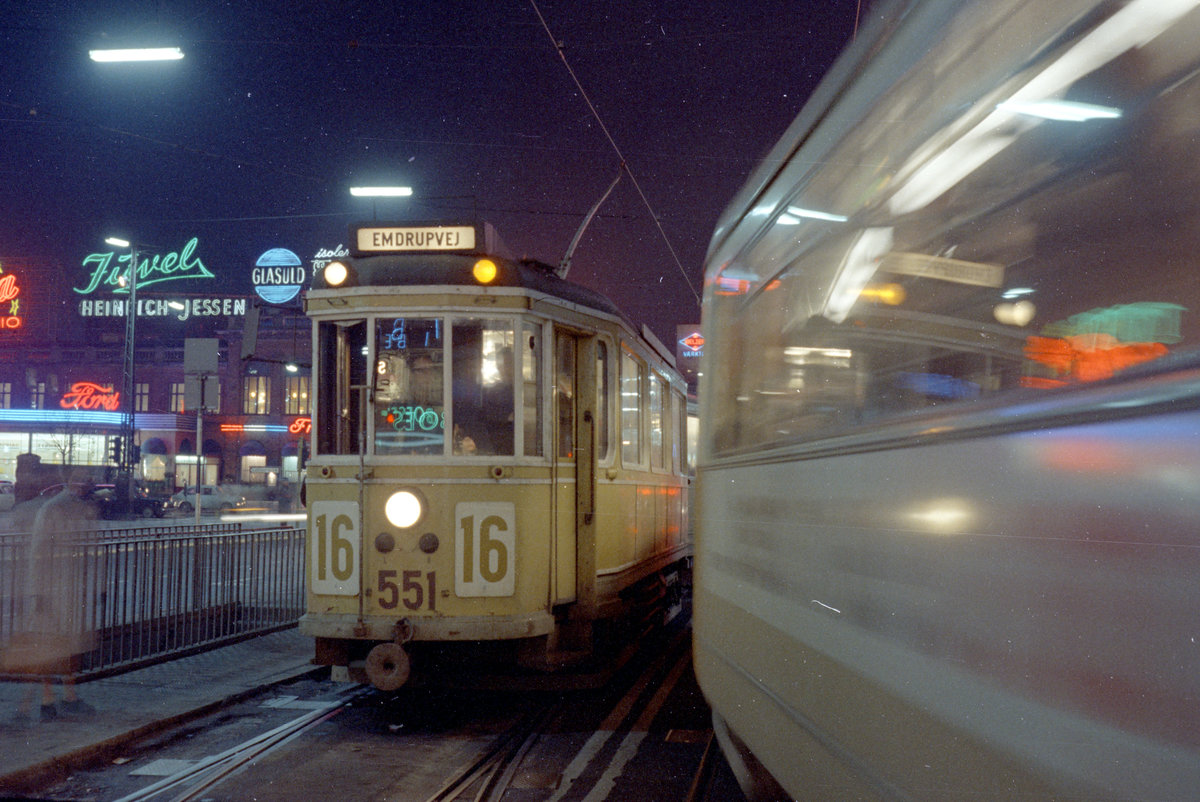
[706,4,1200,451]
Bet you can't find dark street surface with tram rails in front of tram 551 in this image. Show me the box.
[76,627,728,802]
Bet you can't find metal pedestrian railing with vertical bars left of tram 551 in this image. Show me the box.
[0,527,305,680]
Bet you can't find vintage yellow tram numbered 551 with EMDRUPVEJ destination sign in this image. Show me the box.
[300,223,691,689]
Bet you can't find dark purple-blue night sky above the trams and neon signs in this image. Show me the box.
[0,0,869,342]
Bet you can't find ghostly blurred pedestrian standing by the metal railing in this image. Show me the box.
[0,477,94,724]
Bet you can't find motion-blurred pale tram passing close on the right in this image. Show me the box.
[694,0,1200,800]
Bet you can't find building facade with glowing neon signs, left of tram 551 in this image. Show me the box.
[0,240,312,490]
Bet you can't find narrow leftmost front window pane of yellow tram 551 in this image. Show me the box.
[317,321,367,454]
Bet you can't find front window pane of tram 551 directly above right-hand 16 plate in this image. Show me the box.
[451,318,516,456]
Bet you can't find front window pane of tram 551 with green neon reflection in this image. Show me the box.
[373,317,445,455]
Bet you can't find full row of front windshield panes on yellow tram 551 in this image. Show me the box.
[318,317,542,456]
